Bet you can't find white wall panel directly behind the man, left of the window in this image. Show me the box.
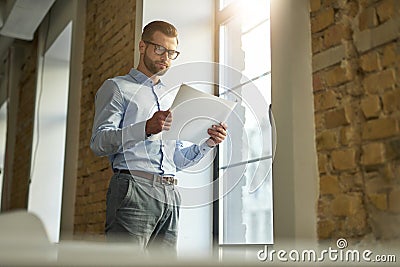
[141,0,215,259]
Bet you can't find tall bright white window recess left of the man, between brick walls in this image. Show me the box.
[28,24,72,242]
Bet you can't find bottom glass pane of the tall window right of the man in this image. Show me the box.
[220,160,273,244]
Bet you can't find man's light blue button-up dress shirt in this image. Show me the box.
[90,69,212,176]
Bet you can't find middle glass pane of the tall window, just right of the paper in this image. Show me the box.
[221,75,272,170]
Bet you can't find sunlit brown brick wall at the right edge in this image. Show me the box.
[310,0,400,240]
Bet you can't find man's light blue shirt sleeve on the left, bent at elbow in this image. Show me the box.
[90,80,146,156]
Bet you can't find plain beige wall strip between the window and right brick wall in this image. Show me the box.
[271,0,318,244]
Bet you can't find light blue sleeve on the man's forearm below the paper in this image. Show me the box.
[174,141,213,171]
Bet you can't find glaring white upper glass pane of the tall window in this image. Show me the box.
[242,20,271,79]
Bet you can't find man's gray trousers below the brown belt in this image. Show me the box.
[105,173,181,256]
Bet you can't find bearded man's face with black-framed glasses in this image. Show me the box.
[143,31,178,76]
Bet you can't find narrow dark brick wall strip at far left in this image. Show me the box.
[3,39,37,210]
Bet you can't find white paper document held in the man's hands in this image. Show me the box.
[159,84,236,144]
